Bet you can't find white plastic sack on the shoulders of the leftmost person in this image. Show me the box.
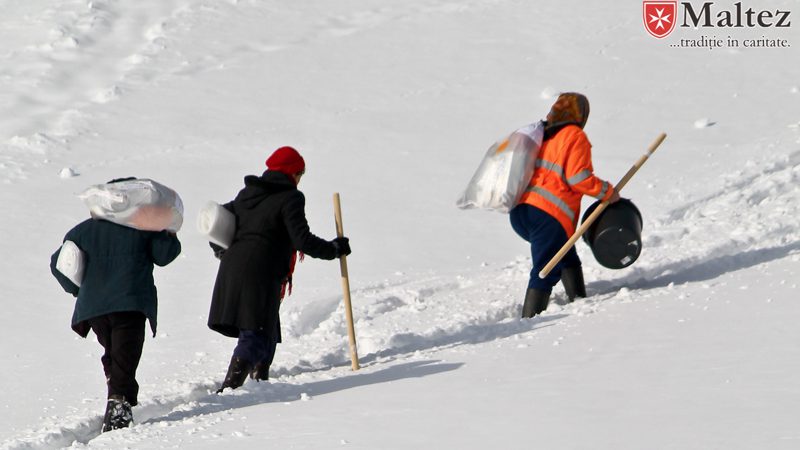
[78,178,183,232]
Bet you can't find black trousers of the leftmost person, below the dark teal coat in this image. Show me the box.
[88,311,146,406]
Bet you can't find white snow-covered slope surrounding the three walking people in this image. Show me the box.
[0,0,800,449]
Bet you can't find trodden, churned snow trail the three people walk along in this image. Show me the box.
[2,142,800,449]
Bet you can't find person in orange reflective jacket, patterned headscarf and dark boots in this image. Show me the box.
[510,92,619,317]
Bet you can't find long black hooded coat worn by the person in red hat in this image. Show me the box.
[208,171,336,340]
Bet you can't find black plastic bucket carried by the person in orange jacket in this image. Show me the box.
[581,198,642,269]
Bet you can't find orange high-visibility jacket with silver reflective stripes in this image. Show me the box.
[520,125,614,236]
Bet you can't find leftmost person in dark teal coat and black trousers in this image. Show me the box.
[50,178,181,432]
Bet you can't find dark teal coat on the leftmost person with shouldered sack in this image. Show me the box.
[50,219,181,337]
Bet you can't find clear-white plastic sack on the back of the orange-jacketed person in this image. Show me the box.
[456,121,544,213]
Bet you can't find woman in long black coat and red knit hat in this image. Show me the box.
[208,147,350,392]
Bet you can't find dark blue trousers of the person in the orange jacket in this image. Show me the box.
[509,203,581,292]
